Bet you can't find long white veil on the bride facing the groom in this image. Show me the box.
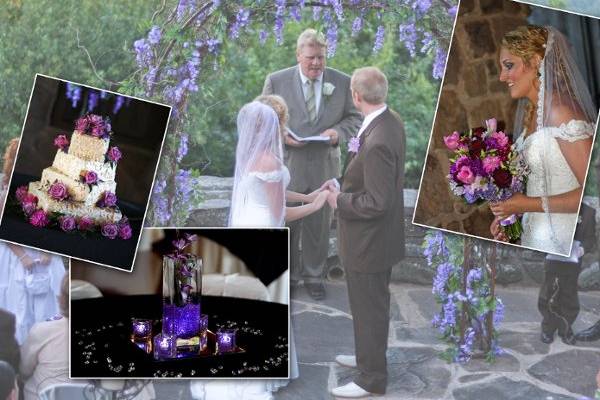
[228,101,285,226]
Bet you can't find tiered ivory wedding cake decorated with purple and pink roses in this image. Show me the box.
[17,114,130,239]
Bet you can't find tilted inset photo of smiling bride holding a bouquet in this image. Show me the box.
[413,0,600,257]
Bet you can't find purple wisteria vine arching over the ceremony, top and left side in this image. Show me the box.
[122,0,456,226]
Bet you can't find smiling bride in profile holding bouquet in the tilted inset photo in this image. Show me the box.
[490,25,597,256]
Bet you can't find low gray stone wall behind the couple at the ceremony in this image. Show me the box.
[187,176,600,289]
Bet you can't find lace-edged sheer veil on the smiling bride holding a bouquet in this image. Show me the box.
[514,26,597,254]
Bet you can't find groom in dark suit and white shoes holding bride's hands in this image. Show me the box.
[324,67,405,398]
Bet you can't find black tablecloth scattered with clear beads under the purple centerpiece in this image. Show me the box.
[71,295,288,378]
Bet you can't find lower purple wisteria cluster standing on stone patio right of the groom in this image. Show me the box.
[423,231,504,363]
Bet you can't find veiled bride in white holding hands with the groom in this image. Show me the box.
[191,96,329,400]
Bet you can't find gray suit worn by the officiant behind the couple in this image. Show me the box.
[263,65,362,282]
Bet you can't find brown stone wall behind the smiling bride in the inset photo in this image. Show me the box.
[415,0,529,237]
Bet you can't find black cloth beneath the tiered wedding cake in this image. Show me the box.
[0,173,144,271]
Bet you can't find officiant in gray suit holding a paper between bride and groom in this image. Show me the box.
[263,29,362,300]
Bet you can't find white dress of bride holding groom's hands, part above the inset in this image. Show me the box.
[229,165,290,227]
